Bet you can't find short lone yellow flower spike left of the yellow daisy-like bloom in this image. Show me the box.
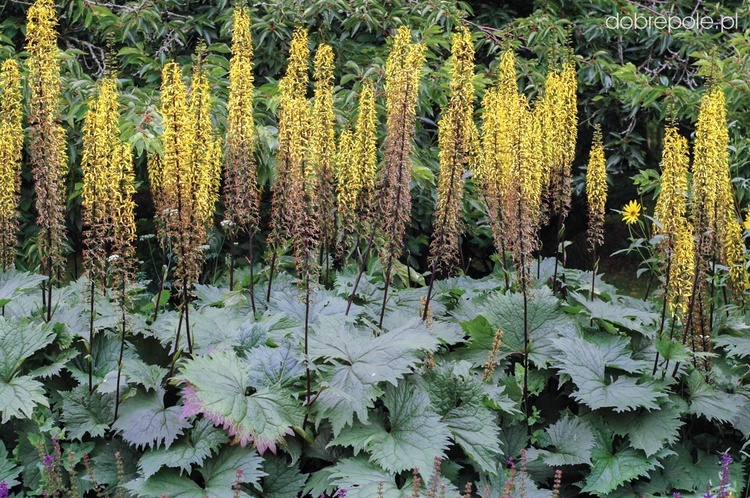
[586,125,607,249]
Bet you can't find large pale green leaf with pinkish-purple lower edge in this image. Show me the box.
[176,351,304,454]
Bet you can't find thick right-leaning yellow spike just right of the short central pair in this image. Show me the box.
[376,26,425,266]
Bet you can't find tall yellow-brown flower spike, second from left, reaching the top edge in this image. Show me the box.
[26,0,68,282]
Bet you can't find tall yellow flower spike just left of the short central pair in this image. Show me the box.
[305,44,336,268]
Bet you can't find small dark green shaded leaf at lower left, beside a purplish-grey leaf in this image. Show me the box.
[59,385,114,440]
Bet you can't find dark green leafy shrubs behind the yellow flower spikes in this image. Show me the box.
[0,0,750,287]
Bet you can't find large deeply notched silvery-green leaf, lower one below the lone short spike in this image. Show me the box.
[554,336,666,412]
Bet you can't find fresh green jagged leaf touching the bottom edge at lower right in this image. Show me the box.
[581,431,656,496]
